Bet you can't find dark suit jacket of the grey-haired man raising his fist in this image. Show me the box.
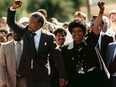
[7,9,66,80]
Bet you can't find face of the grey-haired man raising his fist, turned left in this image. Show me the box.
[28,16,42,32]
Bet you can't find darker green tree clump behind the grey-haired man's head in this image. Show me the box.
[28,0,77,21]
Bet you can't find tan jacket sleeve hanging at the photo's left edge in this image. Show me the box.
[0,45,7,86]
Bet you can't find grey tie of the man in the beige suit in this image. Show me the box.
[16,41,22,69]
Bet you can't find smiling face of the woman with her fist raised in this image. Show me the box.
[72,27,84,44]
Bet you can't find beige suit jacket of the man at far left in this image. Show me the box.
[0,40,24,87]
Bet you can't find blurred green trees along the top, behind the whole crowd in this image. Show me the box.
[0,0,116,22]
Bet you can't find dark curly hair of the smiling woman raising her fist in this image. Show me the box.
[68,18,86,34]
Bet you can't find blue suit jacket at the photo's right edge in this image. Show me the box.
[107,42,116,68]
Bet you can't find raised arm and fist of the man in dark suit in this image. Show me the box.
[7,0,23,37]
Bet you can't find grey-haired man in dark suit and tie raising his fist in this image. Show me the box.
[7,0,66,87]
